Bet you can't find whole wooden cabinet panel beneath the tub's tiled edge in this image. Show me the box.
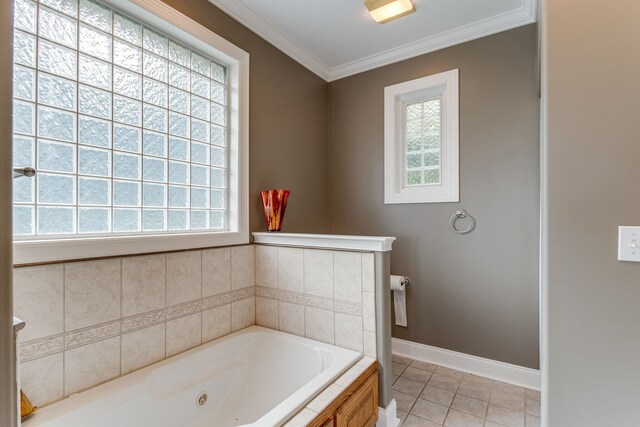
[308,363,378,427]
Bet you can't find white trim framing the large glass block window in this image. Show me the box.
[13,0,249,264]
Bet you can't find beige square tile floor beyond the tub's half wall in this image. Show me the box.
[393,355,540,427]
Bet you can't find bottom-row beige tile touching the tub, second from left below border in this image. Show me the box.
[64,337,120,396]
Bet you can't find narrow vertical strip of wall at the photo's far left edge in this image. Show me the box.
[0,1,16,427]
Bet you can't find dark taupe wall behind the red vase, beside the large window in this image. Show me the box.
[164,0,329,233]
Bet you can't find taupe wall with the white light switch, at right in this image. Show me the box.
[543,0,640,427]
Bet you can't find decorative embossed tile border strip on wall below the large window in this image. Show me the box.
[20,286,256,362]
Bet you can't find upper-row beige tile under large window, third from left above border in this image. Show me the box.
[122,255,166,317]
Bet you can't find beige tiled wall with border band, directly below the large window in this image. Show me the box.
[14,245,256,406]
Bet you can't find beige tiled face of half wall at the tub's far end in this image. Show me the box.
[256,245,376,357]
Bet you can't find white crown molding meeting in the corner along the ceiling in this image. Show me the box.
[209,0,538,82]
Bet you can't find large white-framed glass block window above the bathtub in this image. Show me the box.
[13,0,249,263]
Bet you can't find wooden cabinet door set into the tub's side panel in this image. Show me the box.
[335,372,378,427]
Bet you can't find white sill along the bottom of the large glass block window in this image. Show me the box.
[13,231,249,265]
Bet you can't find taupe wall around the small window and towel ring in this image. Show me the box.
[329,26,539,368]
